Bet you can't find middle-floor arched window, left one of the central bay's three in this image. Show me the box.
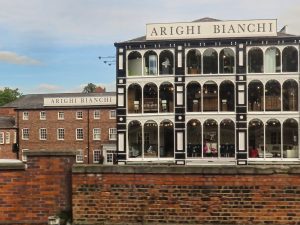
[186,82,201,112]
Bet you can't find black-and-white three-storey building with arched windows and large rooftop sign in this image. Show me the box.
[115,18,300,165]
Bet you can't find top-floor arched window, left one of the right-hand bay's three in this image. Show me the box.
[248,48,264,73]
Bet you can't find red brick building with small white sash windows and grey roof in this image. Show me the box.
[0,92,116,164]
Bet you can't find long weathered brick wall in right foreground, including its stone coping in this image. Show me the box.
[72,165,300,224]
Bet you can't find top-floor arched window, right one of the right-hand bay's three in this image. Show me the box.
[282,46,298,72]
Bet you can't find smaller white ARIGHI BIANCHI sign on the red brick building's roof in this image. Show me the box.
[44,96,116,106]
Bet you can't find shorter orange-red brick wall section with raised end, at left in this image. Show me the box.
[0,152,75,224]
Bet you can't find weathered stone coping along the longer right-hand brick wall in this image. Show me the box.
[72,164,300,175]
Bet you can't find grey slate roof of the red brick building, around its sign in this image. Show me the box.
[2,92,116,109]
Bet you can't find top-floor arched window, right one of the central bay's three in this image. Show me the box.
[219,48,234,73]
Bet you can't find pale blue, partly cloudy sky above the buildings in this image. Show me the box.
[0,0,300,94]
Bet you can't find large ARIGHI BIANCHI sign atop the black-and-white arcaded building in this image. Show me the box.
[146,19,277,40]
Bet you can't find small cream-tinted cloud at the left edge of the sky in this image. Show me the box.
[0,51,42,65]
